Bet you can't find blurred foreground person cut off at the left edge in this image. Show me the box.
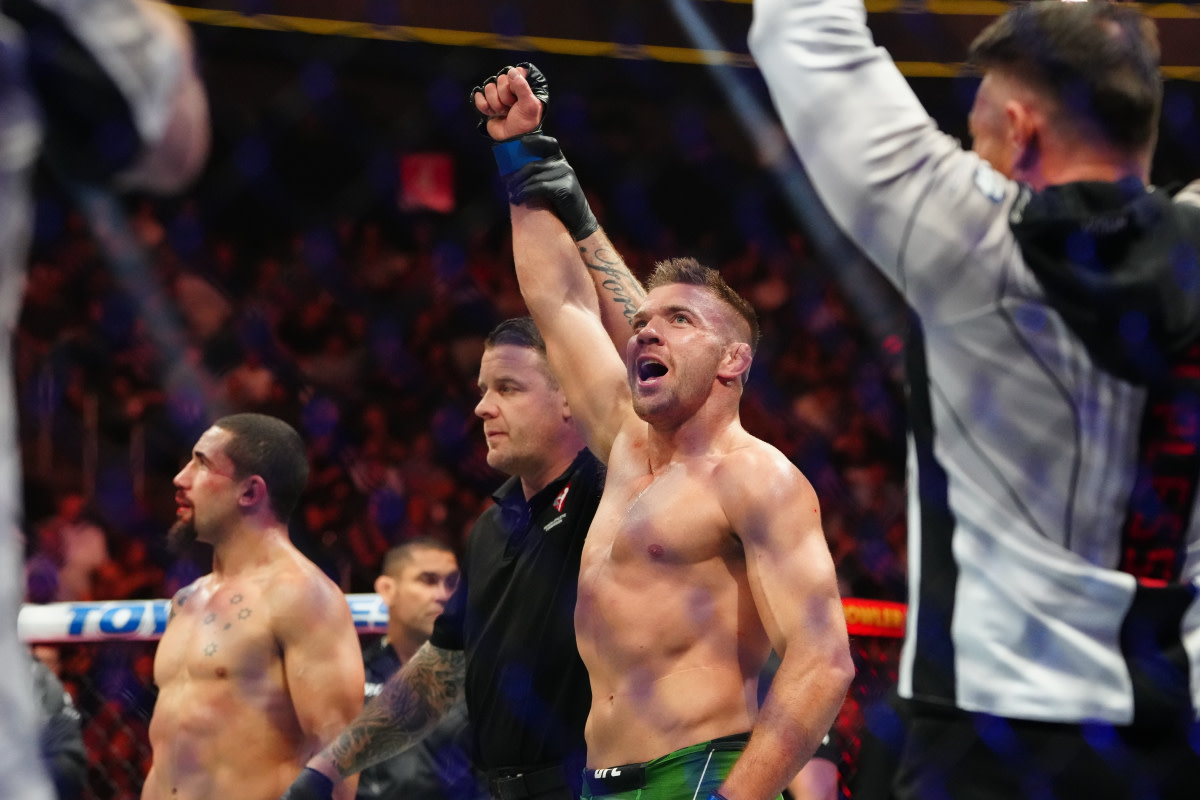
[0,0,210,800]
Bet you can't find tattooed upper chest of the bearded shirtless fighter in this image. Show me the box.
[155,584,281,686]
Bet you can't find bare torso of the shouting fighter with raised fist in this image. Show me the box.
[575,429,770,768]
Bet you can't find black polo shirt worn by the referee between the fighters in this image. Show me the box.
[430,450,605,794]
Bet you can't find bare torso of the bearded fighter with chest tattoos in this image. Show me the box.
[142,567,302,800]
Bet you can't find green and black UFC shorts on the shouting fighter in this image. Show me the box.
[583,733,782,800]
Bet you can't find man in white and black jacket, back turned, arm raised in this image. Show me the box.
[750,0,1200,800]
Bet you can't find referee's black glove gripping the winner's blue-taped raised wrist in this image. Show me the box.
[492,133,600,241]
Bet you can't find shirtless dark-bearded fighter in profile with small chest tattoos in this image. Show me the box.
[142,414,362,800]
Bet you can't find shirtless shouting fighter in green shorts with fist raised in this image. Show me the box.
[475,68,853,800]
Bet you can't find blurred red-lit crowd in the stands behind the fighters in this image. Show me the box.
[17,204,904,602]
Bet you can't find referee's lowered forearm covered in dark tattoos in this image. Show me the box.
[330,643,467,777]
